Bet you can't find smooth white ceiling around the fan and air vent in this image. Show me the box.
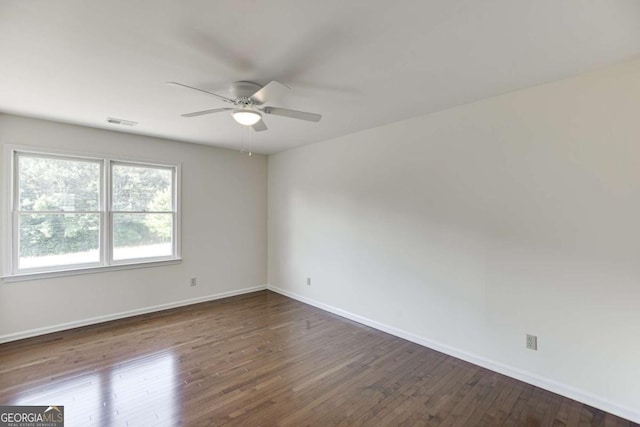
[0,0,640,153]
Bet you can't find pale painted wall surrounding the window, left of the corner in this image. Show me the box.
[0,114,267,341]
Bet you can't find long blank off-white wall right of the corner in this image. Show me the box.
[268,62,640,422]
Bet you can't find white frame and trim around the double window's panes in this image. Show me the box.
[2,145,181,282]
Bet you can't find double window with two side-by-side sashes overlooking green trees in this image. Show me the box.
[9,150,178,275]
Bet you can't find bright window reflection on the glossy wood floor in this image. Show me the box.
[11,353,180,427]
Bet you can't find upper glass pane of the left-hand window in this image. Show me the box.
[18,155,100,211]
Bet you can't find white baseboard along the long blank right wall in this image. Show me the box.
[267,285,640,423]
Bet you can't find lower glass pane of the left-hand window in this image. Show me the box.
[18,213,100,269]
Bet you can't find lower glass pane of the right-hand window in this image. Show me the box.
[113,213,173,260]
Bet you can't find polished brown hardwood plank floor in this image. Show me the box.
[0,291,637,427]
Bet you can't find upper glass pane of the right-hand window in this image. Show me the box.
[112,164,173,212]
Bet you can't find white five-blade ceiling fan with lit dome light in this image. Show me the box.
[167,80,322,132]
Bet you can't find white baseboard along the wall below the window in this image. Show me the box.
[0,285,267,344]
